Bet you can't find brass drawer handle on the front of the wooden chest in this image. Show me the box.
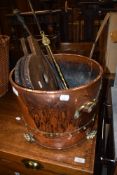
[22,159,43,170]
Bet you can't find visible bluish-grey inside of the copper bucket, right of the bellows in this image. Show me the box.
[58,56,100,88]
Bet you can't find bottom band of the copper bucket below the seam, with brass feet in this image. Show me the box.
[25,114,95,150]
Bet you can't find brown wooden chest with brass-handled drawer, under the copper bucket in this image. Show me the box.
[0,92,96,175]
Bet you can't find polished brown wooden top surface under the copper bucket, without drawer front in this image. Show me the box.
[0,92,96,174]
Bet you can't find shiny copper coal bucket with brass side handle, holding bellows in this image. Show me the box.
[10,54,103,149]
